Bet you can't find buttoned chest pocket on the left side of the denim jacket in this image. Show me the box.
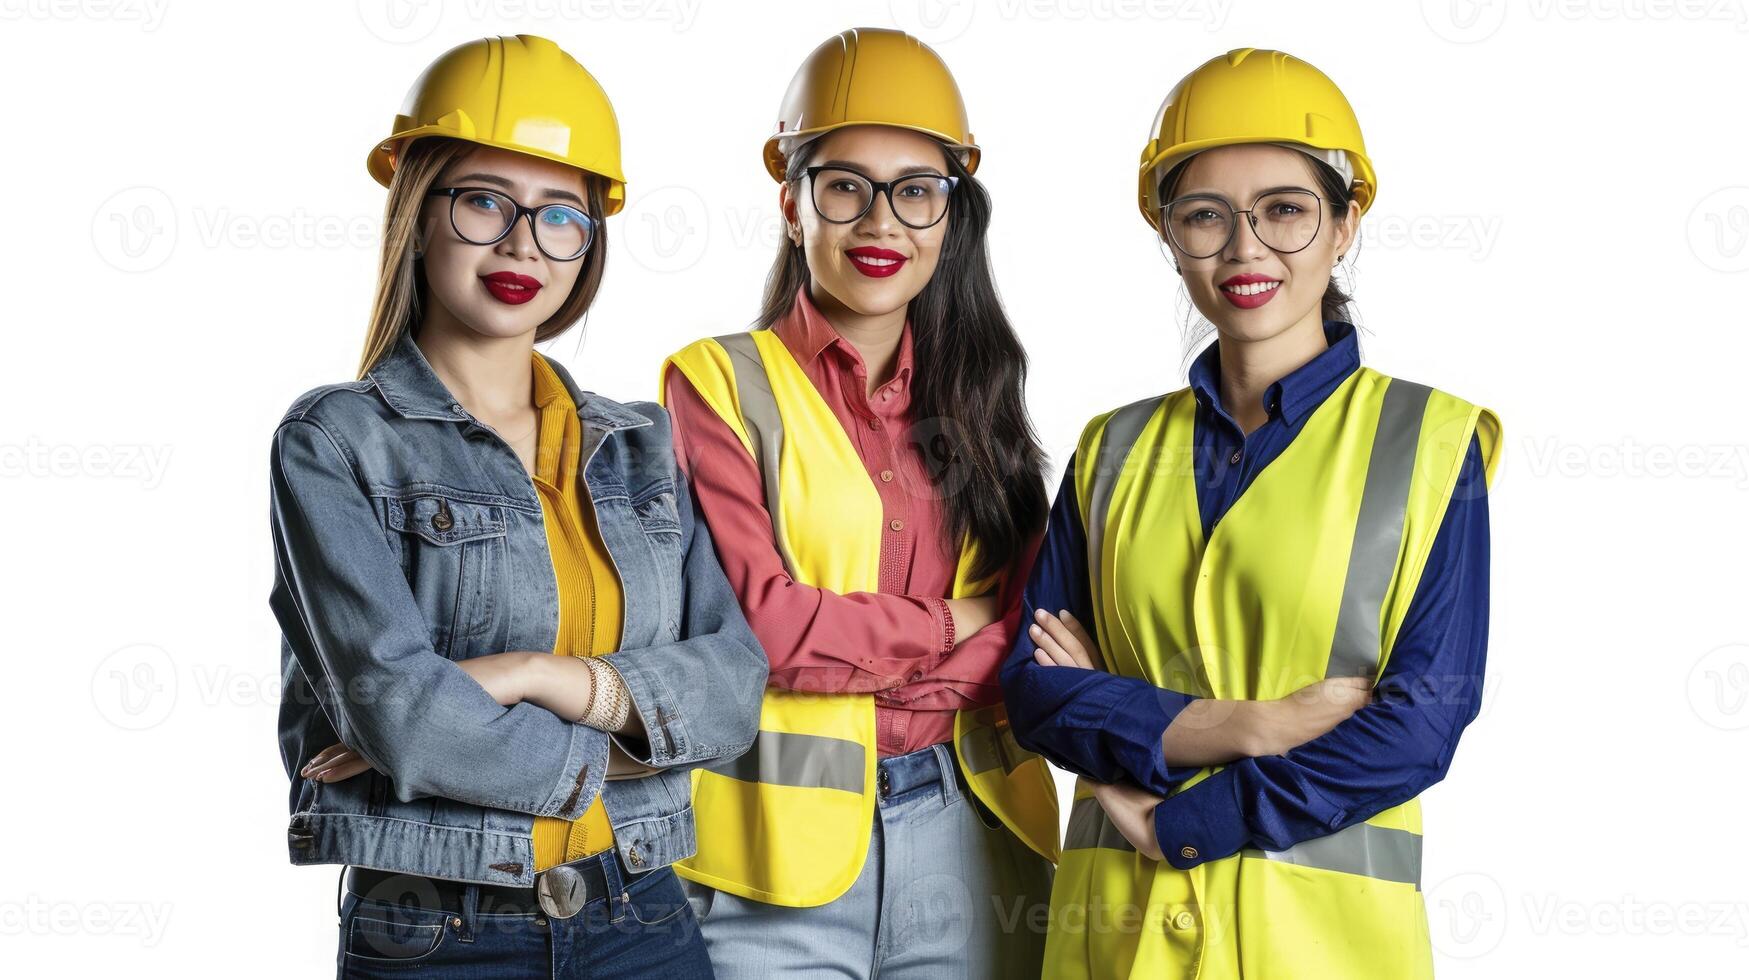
[385,485,507,656]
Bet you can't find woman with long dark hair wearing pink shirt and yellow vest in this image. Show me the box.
[663,28,1058,978]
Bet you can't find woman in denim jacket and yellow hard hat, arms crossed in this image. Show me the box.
[271,35,766,980]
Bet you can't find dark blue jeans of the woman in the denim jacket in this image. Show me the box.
[338,851,714,980]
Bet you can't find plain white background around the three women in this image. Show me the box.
[0,0,1749,978]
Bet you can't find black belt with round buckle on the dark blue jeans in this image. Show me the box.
[346,849,622,919]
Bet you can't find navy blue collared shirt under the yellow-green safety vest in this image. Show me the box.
[1002,320,1488,868]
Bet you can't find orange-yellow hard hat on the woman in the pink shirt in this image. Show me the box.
[764,28,978,182]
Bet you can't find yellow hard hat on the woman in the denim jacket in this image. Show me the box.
[367,33,626,214]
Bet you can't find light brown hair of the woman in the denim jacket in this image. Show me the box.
[359,137,607,378]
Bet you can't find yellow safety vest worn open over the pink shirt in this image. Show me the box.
[663,331,1058,907]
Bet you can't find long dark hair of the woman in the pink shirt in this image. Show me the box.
[759,144,1049,579]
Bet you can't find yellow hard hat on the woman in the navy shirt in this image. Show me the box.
[1139,47,1378,231]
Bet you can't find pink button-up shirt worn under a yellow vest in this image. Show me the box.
[665,287,1037,756]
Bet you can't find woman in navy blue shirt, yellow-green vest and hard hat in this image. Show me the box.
[1002,49,1499,978]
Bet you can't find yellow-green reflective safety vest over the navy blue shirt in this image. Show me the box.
[1044,368,1501,980]
